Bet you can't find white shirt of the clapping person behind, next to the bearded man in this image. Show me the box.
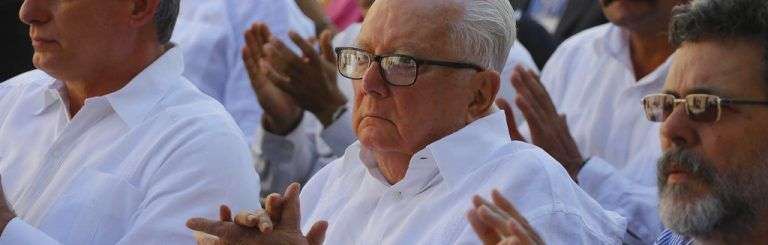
[520,23,670,244]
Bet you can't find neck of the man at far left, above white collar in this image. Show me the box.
[64,45,165,117]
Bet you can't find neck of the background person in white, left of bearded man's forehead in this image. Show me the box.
[629,30,674,80]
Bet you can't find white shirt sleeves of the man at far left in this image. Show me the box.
[0,132,261,245]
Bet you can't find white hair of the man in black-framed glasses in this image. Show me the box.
[450,0,517,72]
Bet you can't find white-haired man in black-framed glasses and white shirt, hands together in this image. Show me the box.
[187,0,626,244]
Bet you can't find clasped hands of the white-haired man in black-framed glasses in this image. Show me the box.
[187,183,328,245]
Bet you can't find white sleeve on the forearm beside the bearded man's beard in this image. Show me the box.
[577,157,663,244]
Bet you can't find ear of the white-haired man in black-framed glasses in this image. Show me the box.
[469,71,501,119]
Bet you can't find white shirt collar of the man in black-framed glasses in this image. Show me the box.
[350,111,511,195]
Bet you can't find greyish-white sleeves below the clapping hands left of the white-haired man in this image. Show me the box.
[252,111,355,195]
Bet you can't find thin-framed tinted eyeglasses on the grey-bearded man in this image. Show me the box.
[643,94,768,122]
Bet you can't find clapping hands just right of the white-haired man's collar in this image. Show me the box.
[497,66,584,181]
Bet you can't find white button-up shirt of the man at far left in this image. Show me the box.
[0,48,260,244]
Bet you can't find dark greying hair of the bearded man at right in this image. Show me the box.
[669,0,768,83]
